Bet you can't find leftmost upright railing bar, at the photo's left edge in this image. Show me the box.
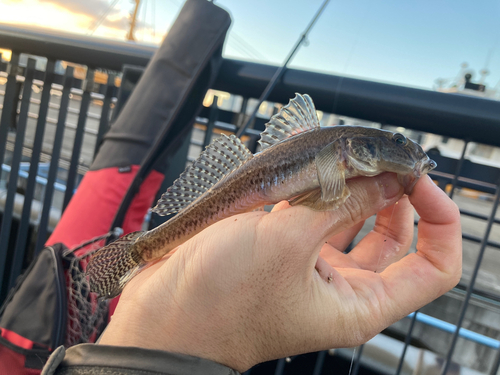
[0,51,19,176]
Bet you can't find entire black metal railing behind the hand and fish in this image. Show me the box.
[0,25,500,374]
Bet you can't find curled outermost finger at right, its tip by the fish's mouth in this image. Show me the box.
[381,176,462,316]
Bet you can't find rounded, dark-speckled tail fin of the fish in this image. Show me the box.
[86,231,144,298]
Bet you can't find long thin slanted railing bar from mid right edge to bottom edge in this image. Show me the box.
[441,184,500,375]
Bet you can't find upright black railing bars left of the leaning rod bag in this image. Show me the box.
[0,51,117,299]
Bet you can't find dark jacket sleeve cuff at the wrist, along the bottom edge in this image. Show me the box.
[43,344,239,375]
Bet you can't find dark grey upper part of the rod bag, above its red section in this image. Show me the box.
[91,0,231,172]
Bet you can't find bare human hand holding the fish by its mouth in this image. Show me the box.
[101,174,462,371]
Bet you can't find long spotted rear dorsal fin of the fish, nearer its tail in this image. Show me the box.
[152,134,253,216]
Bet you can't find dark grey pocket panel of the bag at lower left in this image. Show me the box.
[0,244,67,349]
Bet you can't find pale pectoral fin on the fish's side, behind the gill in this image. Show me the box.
[316,141,350,207]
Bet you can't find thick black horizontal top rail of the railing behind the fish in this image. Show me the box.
[0,24,500,146]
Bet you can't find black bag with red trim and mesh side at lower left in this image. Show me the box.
[0,244,107,375]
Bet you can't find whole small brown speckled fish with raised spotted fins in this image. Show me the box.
[86,94,436,298]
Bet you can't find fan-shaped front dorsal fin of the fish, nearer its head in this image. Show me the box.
[259,93,319,150]
